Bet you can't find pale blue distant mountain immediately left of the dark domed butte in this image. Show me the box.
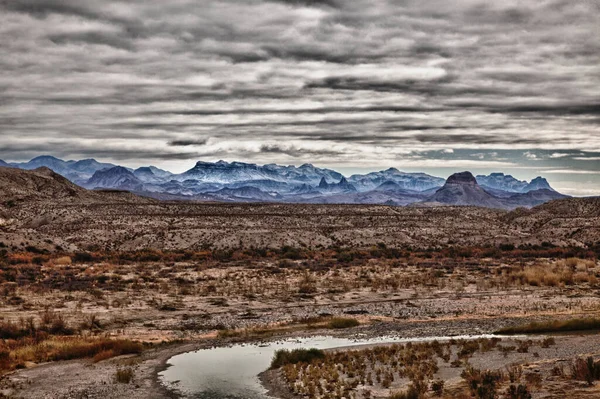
[348,168,444,191]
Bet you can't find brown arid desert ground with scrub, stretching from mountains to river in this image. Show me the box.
[0,170,600,399]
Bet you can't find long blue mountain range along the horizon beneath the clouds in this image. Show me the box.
[0,155,565,209]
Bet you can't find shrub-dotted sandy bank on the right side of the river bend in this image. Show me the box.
[260,334,600,399]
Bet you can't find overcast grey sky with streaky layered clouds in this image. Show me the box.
[0,0,600,195]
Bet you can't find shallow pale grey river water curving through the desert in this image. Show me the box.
[159,335,502,399]
